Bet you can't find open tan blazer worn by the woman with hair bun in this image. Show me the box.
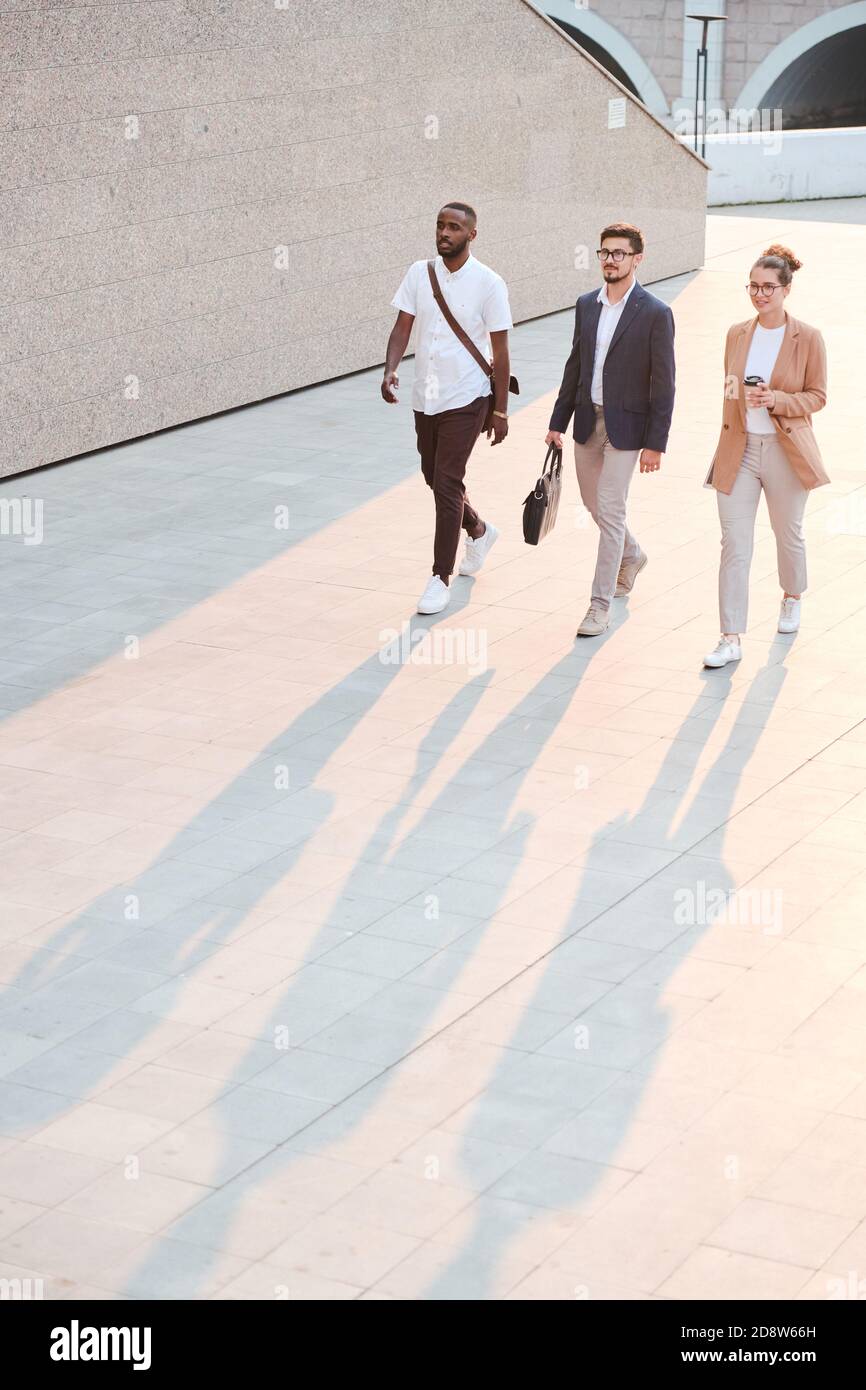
[705,313,830,492]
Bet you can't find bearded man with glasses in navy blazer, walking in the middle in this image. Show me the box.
[545,222,674,637]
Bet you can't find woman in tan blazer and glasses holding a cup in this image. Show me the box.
[703,245,830,666]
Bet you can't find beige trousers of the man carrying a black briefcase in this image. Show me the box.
[574,406,641,609]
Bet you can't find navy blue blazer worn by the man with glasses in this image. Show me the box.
[549,282,674,453]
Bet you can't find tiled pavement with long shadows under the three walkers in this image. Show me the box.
[0,202,866,1300]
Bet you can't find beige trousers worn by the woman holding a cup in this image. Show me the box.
[716,434,808,632]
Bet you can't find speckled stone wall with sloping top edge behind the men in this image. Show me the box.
[0,0,706,474]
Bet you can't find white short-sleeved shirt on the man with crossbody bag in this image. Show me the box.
[391,253,514,416]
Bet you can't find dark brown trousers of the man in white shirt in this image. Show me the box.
[414,396,489,574]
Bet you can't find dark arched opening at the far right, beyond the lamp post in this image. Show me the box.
[755,25,866,131]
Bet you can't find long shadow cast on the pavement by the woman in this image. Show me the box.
[421,644,787,1300]
